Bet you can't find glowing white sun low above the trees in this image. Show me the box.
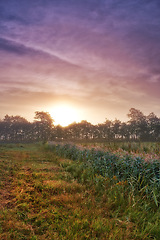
[49,105,80,127]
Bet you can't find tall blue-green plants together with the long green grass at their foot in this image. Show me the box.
[45,144,160,239]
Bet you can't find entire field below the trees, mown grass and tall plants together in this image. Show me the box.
[0,142,160,240]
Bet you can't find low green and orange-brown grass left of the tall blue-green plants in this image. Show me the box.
[0,145,160,240]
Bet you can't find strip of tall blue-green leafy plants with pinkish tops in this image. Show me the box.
[46,144,160,206]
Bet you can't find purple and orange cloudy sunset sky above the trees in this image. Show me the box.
[0,0,160,124]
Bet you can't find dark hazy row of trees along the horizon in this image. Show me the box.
[0,108,160,143]
